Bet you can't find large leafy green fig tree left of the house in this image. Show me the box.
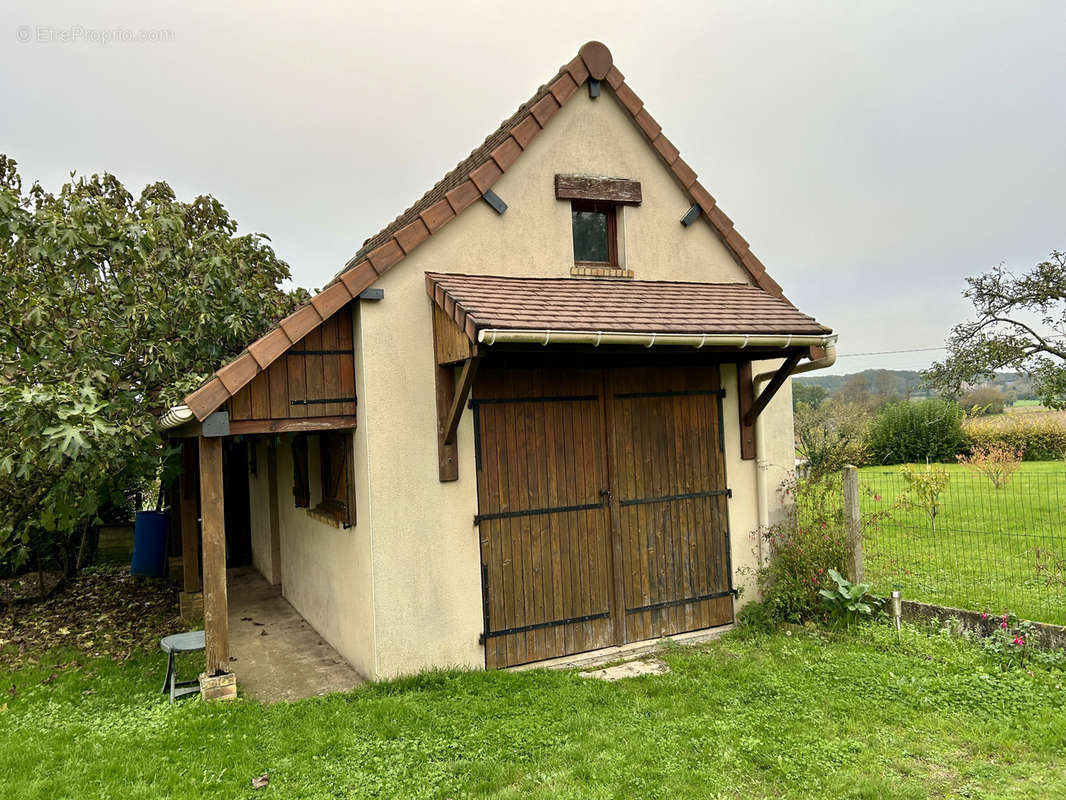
[0,156,307,574]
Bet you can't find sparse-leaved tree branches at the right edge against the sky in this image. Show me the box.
[923,251,1066,409]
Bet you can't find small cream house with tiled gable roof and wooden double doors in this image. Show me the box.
[162,42,835,691]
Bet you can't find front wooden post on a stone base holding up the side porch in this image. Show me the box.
[199,437,229,677]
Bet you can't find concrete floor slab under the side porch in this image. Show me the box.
[227,566,364,703]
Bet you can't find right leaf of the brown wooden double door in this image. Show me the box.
[607,368,732,641]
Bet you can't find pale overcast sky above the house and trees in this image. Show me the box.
[0,0,1066,372]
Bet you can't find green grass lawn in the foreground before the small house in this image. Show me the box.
[0,623,1066,800]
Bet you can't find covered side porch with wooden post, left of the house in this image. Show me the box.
[162,308,362,701]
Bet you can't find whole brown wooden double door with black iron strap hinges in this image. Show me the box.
[473,367,732,668]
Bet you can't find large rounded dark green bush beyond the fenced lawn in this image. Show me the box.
[867,399,965,464]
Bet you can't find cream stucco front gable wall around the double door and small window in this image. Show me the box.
[345,86,792,677]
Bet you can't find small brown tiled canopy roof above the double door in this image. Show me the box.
[425,272,831,340]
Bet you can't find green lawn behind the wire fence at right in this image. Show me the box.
[859,461,1066,624]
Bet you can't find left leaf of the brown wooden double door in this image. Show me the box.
[474,369,615,668]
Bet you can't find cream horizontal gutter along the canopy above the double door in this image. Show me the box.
[478,327,837,350]
